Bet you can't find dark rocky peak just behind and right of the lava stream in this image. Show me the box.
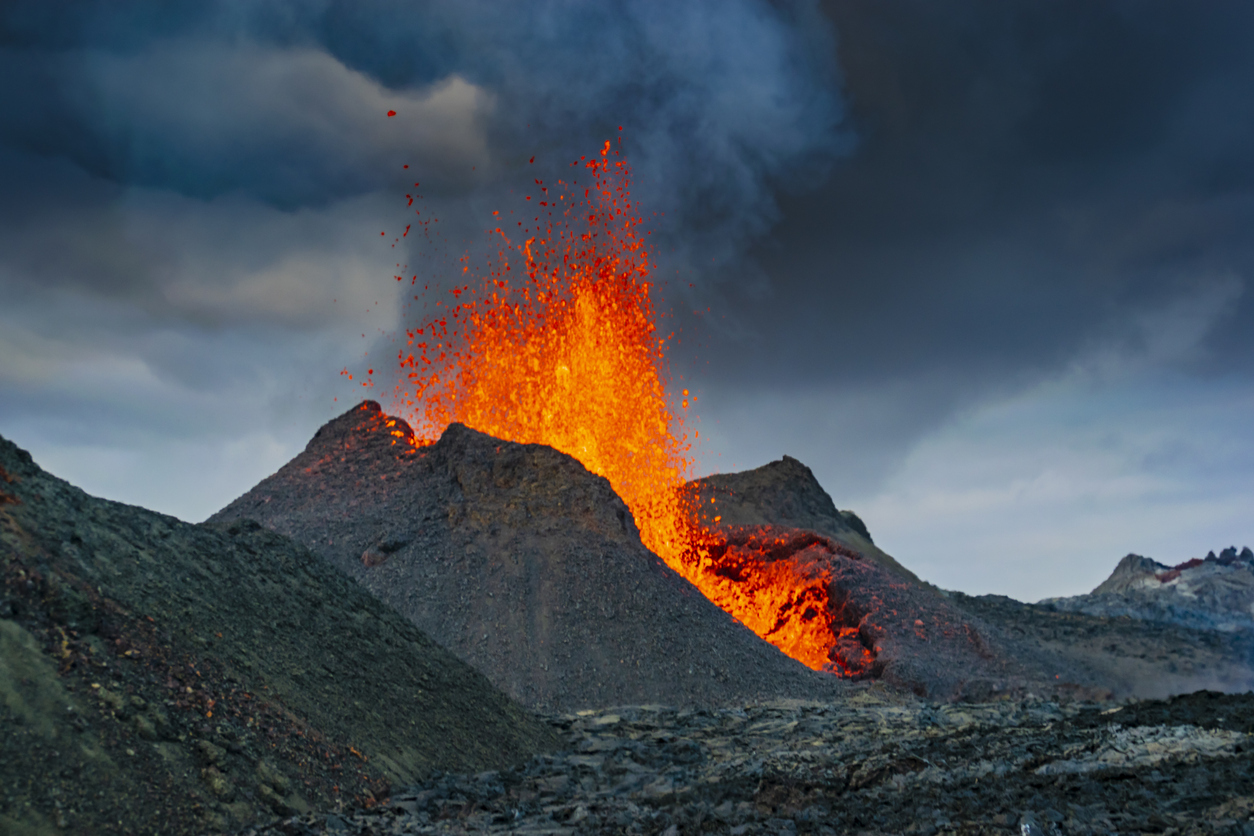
[688,456,919,583]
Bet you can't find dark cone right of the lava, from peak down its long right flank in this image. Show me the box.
[688,456,1109,699]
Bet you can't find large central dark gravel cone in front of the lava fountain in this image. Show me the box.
[211,401,844,709]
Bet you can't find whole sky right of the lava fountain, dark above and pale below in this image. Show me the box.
[681,0,1254,599]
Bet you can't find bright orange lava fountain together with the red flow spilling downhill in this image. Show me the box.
[386,140,870,676]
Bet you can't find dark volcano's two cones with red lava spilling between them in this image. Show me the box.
[211,401,1103,709]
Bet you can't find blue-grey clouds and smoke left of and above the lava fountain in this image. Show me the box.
[0,0,843,518]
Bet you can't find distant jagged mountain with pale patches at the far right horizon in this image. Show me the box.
[1040,546,1254,632]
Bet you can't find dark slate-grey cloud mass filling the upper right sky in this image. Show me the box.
[697,0,1254,392]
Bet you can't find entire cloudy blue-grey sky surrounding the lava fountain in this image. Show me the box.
[0,0,1254,600]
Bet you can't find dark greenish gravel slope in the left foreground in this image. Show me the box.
[0,439,557,835]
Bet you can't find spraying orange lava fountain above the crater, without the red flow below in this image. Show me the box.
[399,142,691,558]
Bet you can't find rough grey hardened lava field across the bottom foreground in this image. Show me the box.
[245,687,1254,836]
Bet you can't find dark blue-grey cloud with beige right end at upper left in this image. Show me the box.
[0,38,492,208]
